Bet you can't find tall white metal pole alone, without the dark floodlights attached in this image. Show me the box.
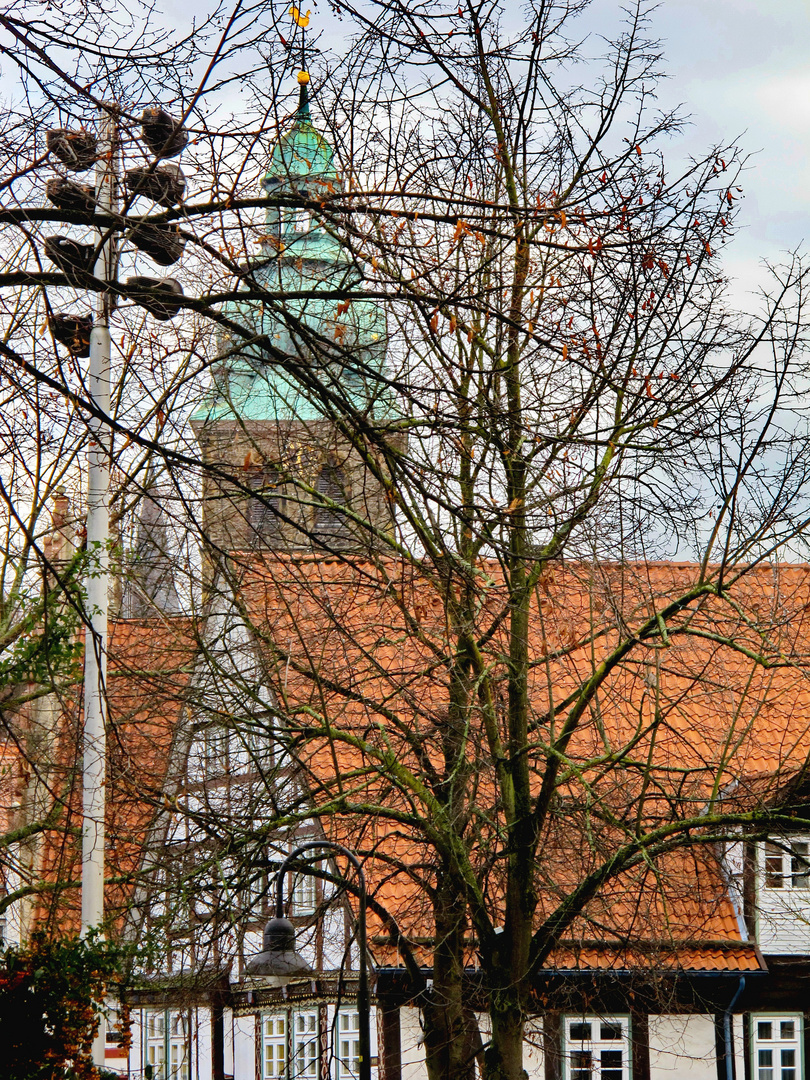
[82,110,117,1066]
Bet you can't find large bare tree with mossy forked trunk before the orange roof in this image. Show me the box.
[0,0,808,1080]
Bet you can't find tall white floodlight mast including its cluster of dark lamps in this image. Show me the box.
[45,105,188,1066]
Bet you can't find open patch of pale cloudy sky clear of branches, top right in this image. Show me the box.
[589,0,810,299]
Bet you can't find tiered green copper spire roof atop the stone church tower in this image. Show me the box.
[192,71,386,422]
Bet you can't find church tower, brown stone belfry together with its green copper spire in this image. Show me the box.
[191,71,394,552]
